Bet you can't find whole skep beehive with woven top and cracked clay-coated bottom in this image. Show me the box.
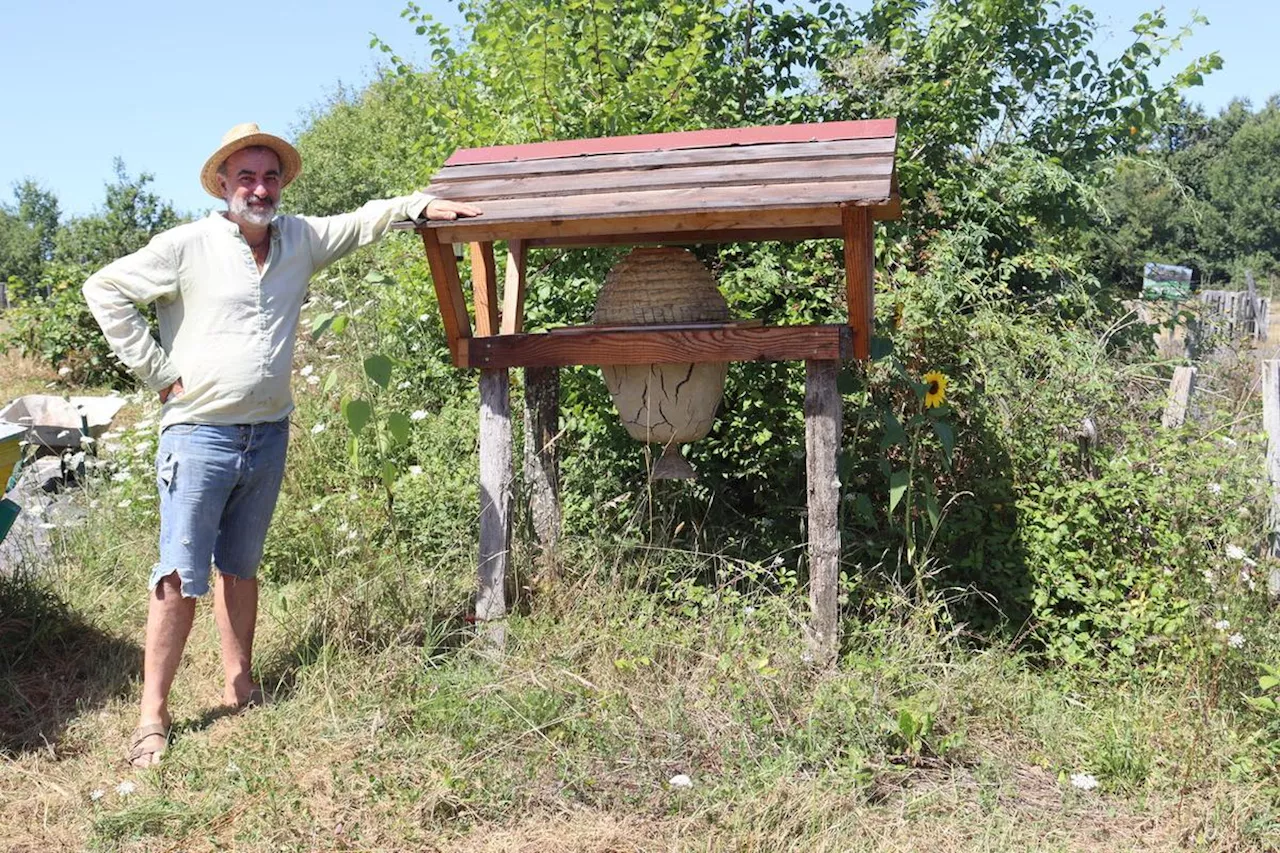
[594,246,728,479]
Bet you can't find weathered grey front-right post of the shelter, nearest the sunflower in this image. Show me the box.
[804,361,842,666]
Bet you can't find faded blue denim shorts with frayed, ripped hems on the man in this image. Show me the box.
[148,419,289,598]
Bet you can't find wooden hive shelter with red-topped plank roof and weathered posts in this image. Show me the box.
[399,119,900,660]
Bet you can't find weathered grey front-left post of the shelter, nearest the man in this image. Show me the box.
[476,368,512,651]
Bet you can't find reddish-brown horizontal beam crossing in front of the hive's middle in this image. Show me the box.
[454,325,856,368]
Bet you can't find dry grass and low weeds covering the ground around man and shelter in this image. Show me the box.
[0,320,1280,853]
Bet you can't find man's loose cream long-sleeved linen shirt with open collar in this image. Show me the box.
[84,192,433,427]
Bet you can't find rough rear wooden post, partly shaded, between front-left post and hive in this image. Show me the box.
[525,368,561,555]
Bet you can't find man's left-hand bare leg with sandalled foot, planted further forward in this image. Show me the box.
[134,571,196,767]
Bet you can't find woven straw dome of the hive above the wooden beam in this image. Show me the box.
[593,246,728,325]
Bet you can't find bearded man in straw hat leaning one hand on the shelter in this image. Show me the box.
[84,124,480,767]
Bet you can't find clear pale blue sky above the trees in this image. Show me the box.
[0,0,1280,214]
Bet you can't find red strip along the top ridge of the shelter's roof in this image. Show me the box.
[444,118,897,167]
